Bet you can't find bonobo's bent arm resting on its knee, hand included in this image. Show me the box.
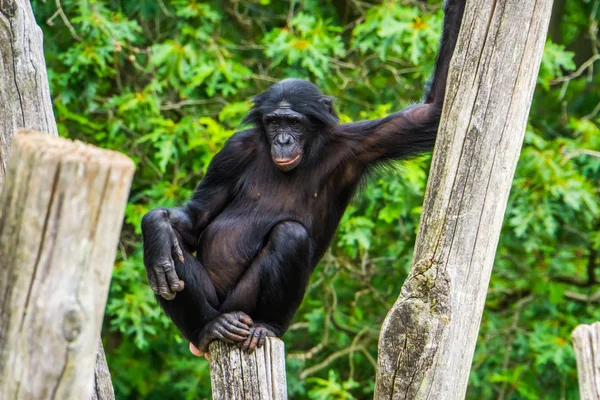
[142,134,247,300]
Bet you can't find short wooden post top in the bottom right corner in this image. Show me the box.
[571,322,600,400]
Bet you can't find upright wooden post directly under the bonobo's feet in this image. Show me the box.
[209,338,287,400]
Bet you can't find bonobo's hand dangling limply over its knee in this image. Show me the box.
[142,209,184,300]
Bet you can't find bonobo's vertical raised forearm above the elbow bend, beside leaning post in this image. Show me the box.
[425,0,466,106]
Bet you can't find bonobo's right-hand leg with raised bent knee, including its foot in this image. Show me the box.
[221,221,312,351]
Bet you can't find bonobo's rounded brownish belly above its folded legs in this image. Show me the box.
[198,209,274,291]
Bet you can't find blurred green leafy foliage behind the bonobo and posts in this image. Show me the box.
[32,0,600,399]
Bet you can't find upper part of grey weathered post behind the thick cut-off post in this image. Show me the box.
[0,0,57,187]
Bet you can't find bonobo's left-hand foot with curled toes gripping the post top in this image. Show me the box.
[196,311,254,355]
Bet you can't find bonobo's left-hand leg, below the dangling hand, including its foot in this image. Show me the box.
[156,250,252,353]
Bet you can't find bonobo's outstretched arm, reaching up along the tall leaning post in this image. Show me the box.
[342,0,466,165]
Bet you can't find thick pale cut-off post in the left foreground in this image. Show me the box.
[0,133,134,400]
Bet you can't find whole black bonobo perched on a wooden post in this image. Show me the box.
[142,0,465,354]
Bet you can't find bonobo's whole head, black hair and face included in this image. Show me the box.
[244,79,338,171]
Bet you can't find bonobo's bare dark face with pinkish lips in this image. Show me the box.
[263,101,308,171]
